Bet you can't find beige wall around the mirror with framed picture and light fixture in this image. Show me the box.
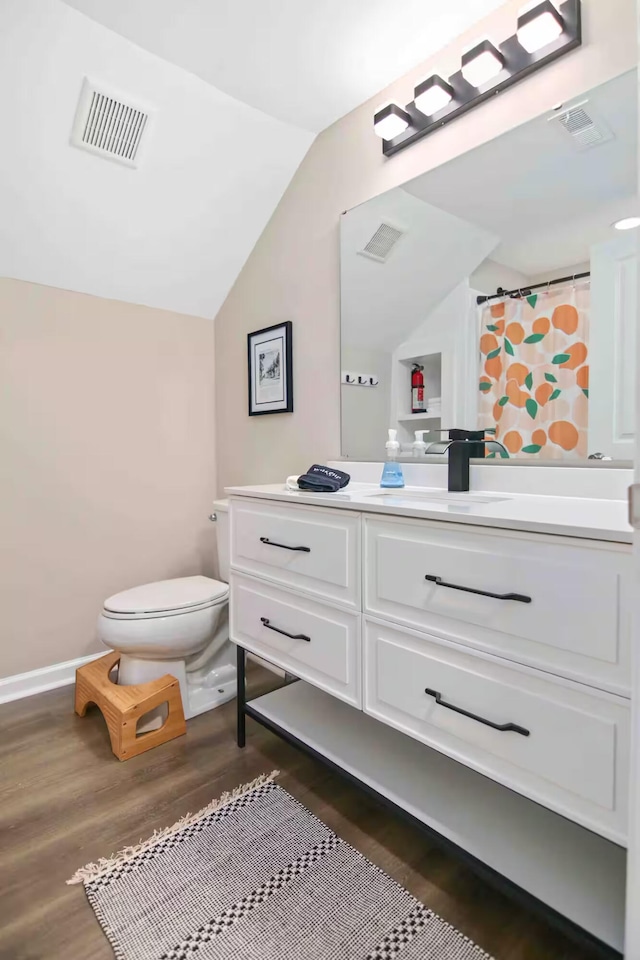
[216,0,637,490]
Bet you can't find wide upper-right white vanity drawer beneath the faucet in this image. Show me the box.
[365,518,631,696]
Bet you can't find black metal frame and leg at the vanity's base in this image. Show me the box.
[236,645,624,960]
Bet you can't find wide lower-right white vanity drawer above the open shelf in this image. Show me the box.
[364,620,630,844]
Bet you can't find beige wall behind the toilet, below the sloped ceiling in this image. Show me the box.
[0,279,215,677]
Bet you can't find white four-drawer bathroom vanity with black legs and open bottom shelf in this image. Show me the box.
[227,483,631,955]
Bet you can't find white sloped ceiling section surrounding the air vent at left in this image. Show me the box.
[0,0,313,317]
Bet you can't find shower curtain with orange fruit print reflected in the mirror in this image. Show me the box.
[479,283,591,459]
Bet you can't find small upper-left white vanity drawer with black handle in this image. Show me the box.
[231,500,360,610]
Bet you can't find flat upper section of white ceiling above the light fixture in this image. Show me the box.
[66,0,504,132]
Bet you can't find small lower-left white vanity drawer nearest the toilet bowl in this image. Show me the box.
[230,573,362,707]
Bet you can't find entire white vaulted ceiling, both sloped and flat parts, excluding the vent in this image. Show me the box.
[0,0,508,317]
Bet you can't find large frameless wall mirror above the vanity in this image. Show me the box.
[341,71,640,462]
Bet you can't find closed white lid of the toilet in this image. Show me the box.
[104,576,229,613]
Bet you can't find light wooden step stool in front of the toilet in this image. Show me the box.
[75,652,187,760]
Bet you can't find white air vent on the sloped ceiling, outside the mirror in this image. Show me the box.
[71,77,151,167]
